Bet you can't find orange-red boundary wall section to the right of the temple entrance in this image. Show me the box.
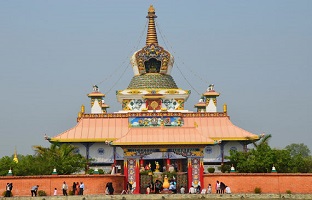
[204,173,312,194]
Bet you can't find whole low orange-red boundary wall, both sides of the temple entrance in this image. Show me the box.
[0,173,312,196]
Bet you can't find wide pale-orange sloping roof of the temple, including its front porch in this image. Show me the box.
[51,112,259,145]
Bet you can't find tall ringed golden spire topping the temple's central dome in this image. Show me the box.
[146,5,158,45]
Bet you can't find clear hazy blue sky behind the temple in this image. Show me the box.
[0,0,312,156]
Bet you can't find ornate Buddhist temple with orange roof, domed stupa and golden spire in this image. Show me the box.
[48,6,259,192]
